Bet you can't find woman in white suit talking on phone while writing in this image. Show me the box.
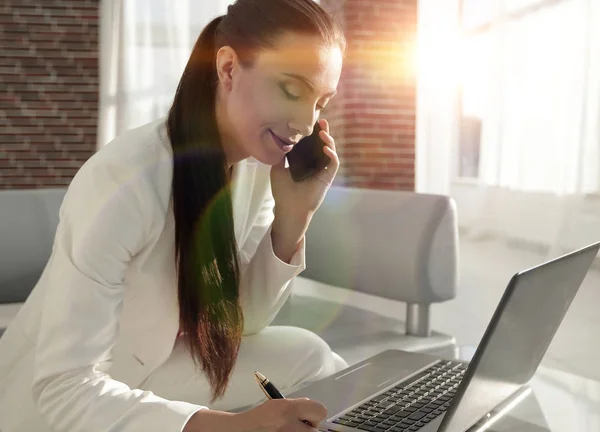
[0,0,347,432]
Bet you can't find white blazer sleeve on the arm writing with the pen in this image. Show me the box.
[32,161,206,432]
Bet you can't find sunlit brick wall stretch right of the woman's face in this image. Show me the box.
[320,0,417,190]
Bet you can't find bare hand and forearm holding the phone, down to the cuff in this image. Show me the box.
[271,119,340,263]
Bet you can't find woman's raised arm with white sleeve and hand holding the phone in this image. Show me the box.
[240,116,340,334]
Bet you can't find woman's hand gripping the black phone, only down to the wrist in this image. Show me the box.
[271,119,340,218]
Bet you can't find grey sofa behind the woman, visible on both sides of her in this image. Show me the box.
[0,186,458,363]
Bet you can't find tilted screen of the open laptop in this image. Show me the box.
[439,243,600,432]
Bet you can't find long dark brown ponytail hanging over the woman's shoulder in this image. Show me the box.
[167,16,243,402]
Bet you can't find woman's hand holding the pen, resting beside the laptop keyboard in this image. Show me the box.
[184,398,327,432]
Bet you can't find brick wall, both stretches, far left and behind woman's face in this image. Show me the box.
[0,0,417,190]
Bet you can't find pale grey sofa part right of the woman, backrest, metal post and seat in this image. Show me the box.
[273,186,458,364]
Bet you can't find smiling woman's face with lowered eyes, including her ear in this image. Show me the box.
[216,33,342,165]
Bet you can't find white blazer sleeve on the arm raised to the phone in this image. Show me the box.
[240,190,306,335]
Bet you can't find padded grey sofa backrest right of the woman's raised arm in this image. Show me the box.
[302,186,458,305]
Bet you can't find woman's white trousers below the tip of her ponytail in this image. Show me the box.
[140,326,348,411]
